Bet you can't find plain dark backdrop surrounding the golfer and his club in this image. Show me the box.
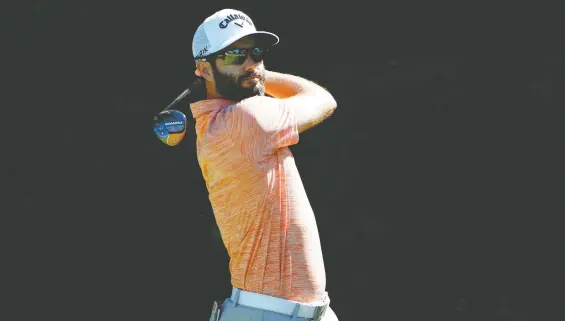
[2,0,563,321]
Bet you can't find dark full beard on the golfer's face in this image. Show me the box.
[213,68,265,101]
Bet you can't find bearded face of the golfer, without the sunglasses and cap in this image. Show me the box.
[211,38,265,101]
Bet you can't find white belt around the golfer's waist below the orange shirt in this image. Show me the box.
[231,287,329,319]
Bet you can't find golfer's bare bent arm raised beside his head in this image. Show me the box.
[265,70,337,132]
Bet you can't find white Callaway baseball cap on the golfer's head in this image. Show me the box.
[192,9,279,59]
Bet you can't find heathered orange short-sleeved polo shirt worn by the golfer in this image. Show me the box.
[191,96,326,303]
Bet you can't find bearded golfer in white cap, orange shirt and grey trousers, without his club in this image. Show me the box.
[190,9,337,321]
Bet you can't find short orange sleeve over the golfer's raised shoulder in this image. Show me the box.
[229,97,299,157]
